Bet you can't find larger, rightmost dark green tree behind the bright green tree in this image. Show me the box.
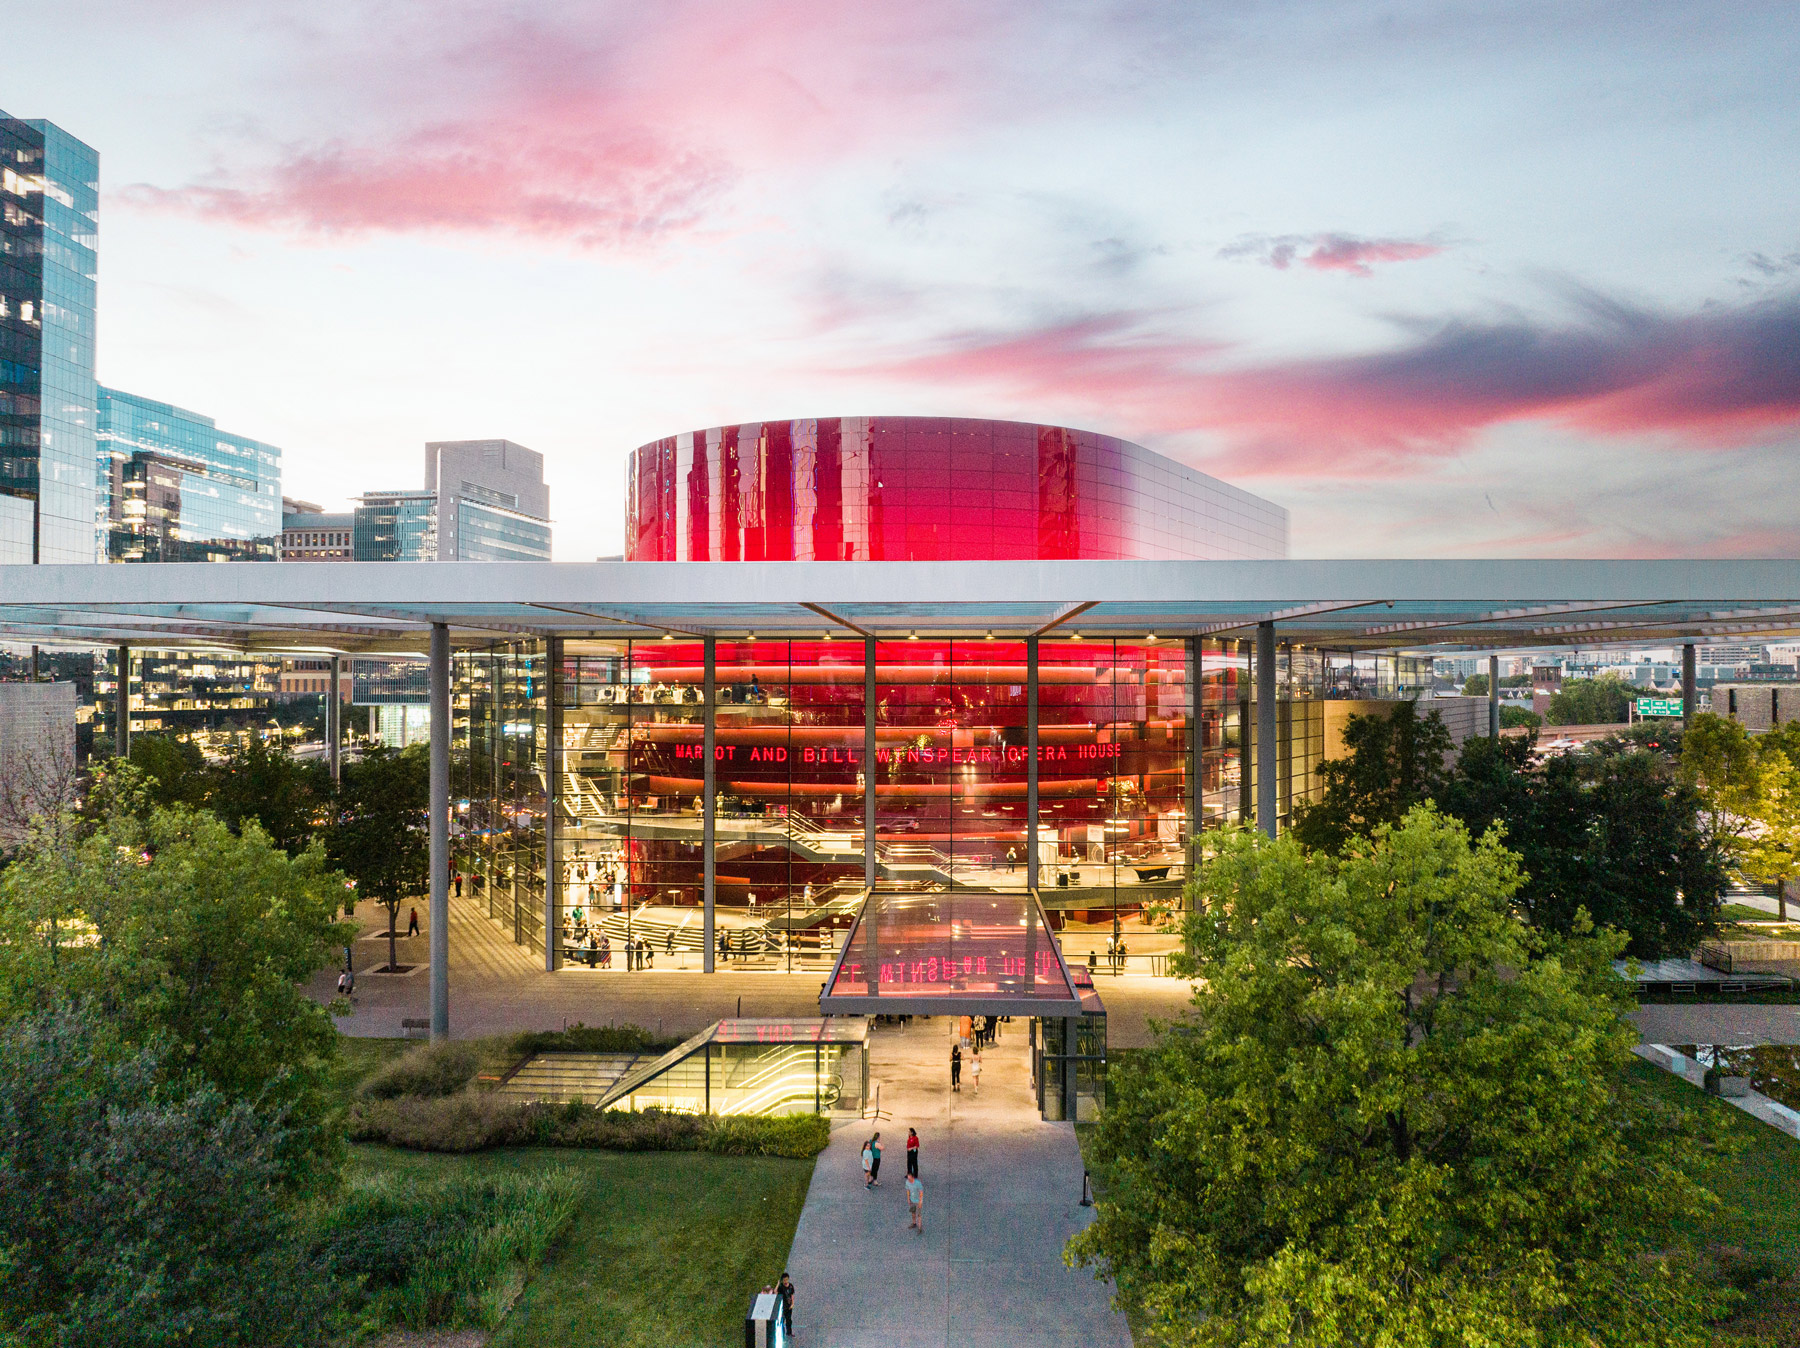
[1438,738,1726,959]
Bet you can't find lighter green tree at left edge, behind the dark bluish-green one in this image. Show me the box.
[0,810,353,1186]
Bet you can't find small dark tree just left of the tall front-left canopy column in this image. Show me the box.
[326,745,432,968]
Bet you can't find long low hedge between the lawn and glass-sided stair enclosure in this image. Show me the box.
[349,1091,832,1159]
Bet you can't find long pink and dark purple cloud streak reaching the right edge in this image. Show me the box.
[838,293,1800,477]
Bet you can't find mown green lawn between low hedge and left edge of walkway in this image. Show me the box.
[349,1146,828,1348]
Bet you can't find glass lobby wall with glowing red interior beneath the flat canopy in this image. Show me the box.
[452,634,1375,970]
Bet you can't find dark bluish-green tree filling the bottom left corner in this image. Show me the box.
[0,1010,335,1348]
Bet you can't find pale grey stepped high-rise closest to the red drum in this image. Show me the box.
[353,439,551,562]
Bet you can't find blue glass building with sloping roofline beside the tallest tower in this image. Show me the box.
[97,387,281,562]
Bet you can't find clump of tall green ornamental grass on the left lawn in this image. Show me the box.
[315,1170,580,1330]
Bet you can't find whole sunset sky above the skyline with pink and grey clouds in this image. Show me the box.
[0,0,1800,562]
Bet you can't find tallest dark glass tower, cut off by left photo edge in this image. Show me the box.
[0,113,101,562]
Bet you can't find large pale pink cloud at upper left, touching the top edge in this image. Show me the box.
[126,0,1010,247]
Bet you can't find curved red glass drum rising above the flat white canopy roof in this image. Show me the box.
[625,418,1287,562]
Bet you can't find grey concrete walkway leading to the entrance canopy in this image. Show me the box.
[788,1017,1130,1348]
